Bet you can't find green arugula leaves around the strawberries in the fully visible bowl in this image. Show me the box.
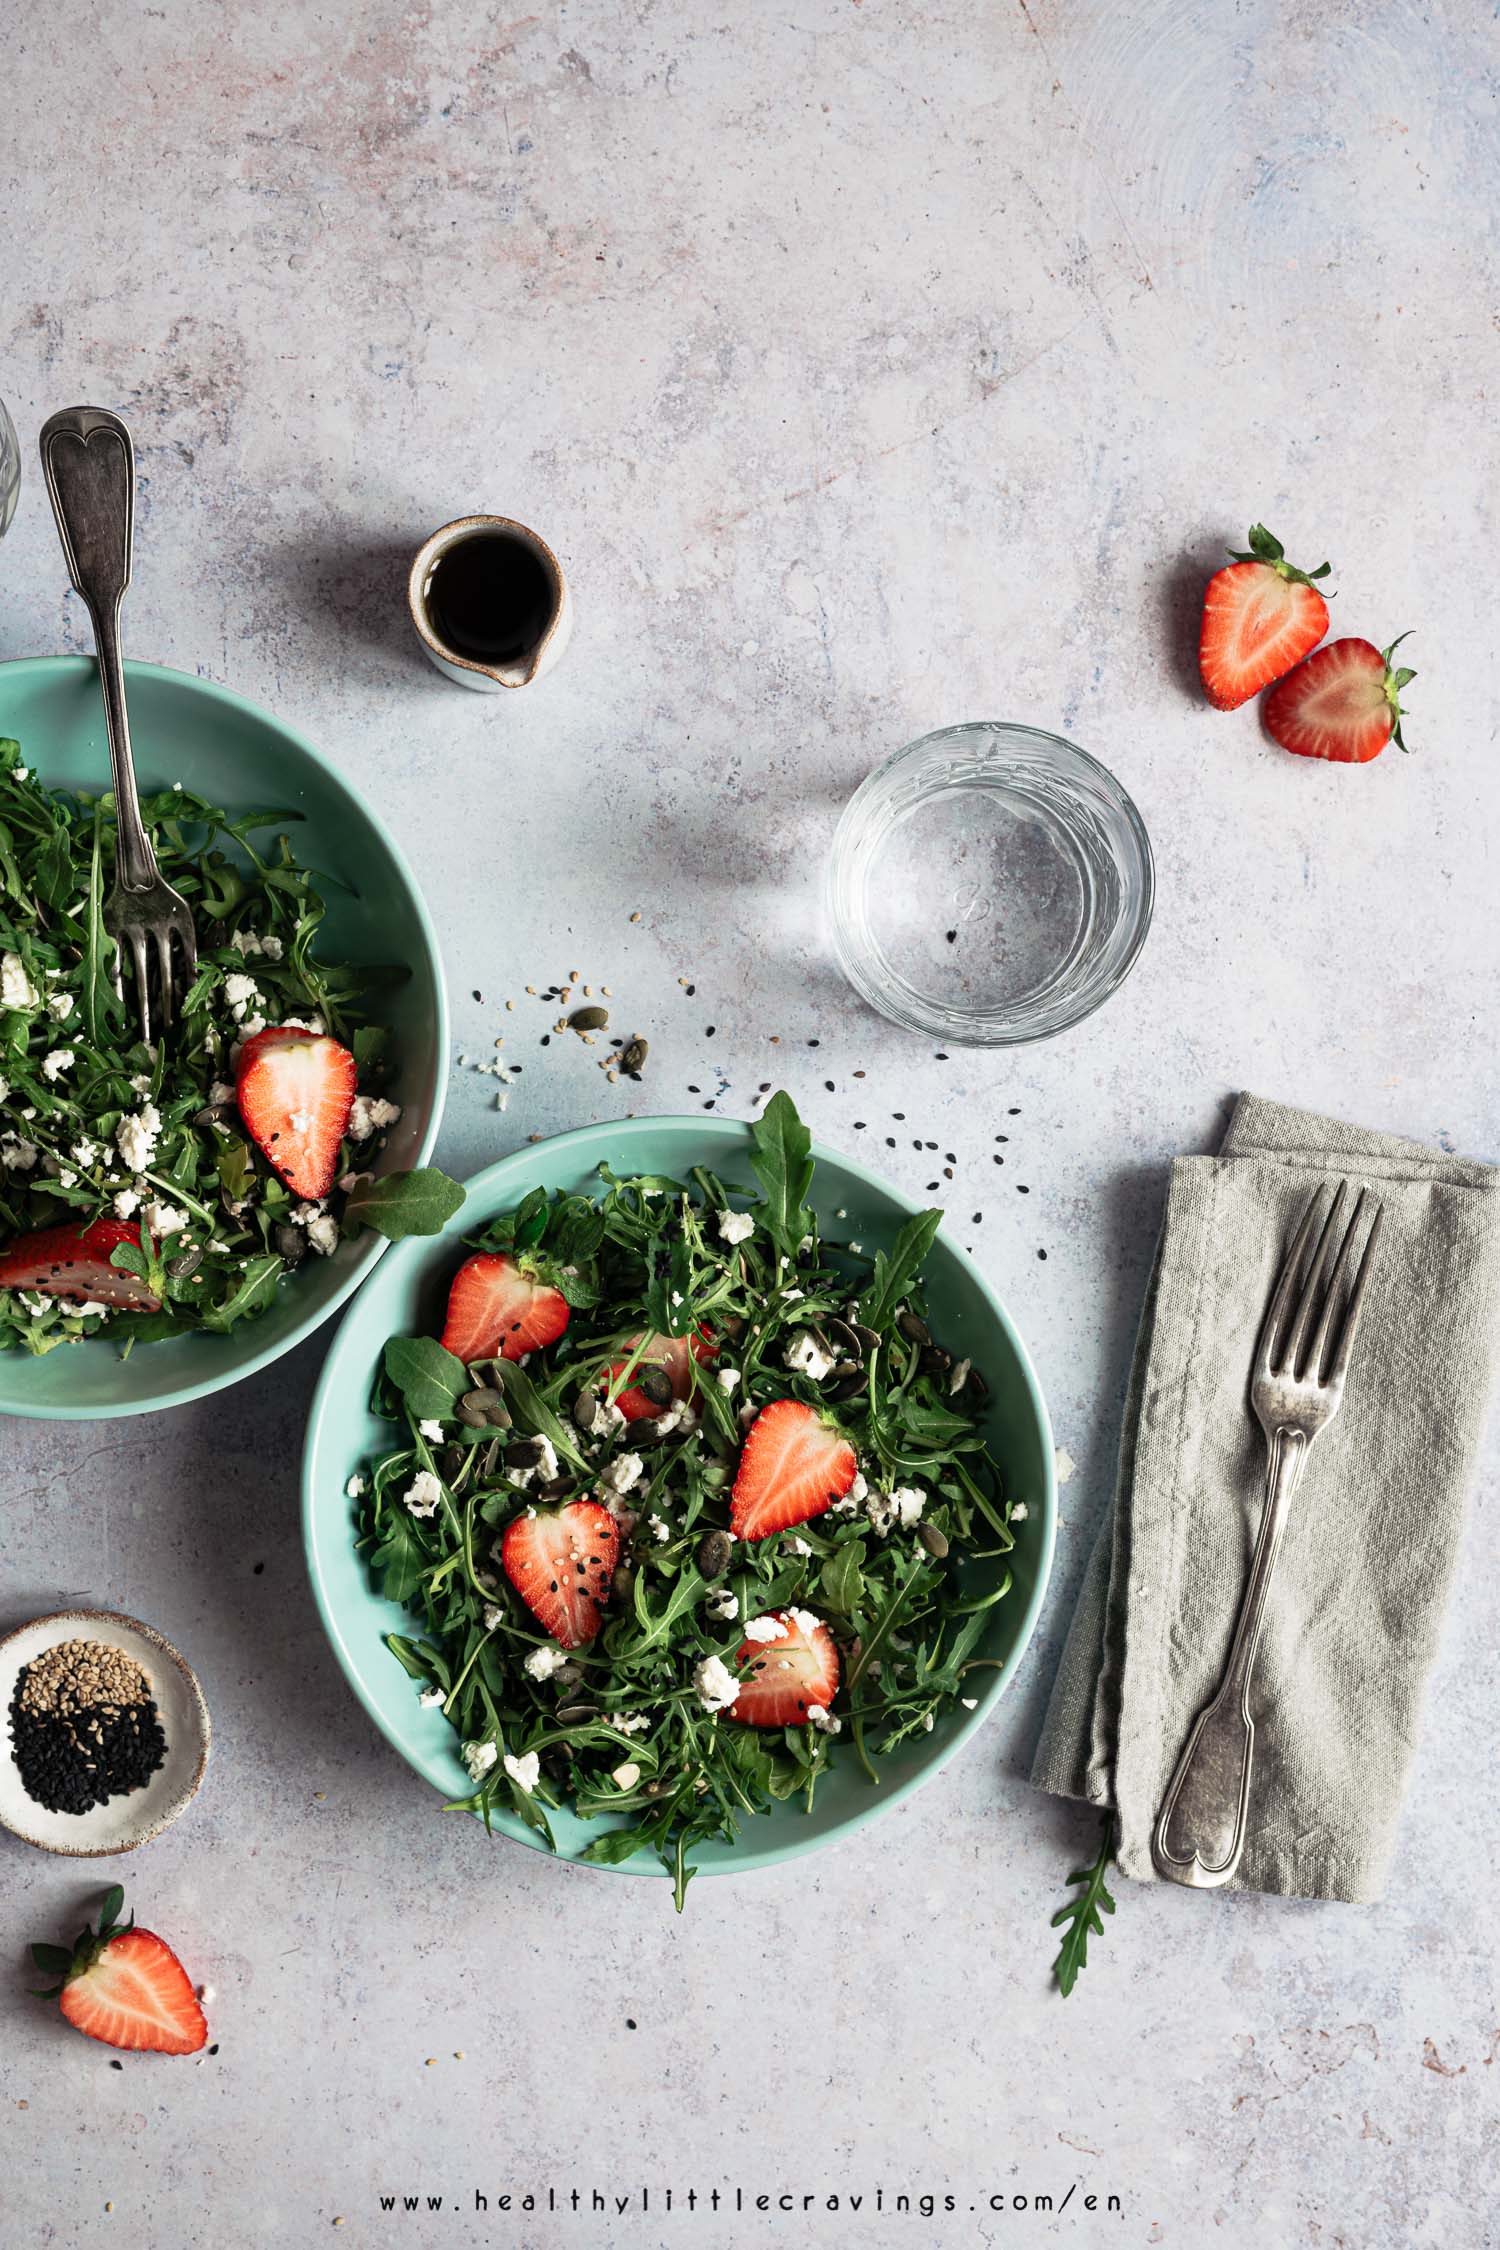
[355,1096,1010,1904]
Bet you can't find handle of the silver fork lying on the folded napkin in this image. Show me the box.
[1151,1427,1309,1890]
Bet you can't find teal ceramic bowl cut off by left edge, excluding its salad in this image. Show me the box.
[0,657,450,1420]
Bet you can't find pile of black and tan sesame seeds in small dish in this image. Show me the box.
[9,1640,166,1814]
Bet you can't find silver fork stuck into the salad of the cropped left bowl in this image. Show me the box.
[40,407,198,1046]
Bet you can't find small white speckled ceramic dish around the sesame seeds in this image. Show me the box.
[0,1609,211,1859]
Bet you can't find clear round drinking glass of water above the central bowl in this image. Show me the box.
[828,722,1154,1046]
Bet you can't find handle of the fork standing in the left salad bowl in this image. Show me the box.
[40,407,157,891]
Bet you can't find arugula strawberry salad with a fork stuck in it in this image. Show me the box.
[0,740,461,1352]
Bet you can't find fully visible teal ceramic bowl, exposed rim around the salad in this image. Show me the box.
[301,1116,1057,1874]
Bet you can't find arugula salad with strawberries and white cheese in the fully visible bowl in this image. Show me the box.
[349,1094,1012,1908]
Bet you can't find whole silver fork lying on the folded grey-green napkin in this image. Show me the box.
[1151,1179,1381,1890]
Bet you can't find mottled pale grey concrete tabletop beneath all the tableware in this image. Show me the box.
[0,0,1500,2250]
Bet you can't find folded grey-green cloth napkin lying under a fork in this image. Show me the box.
[1032,1094,1500,1899]
